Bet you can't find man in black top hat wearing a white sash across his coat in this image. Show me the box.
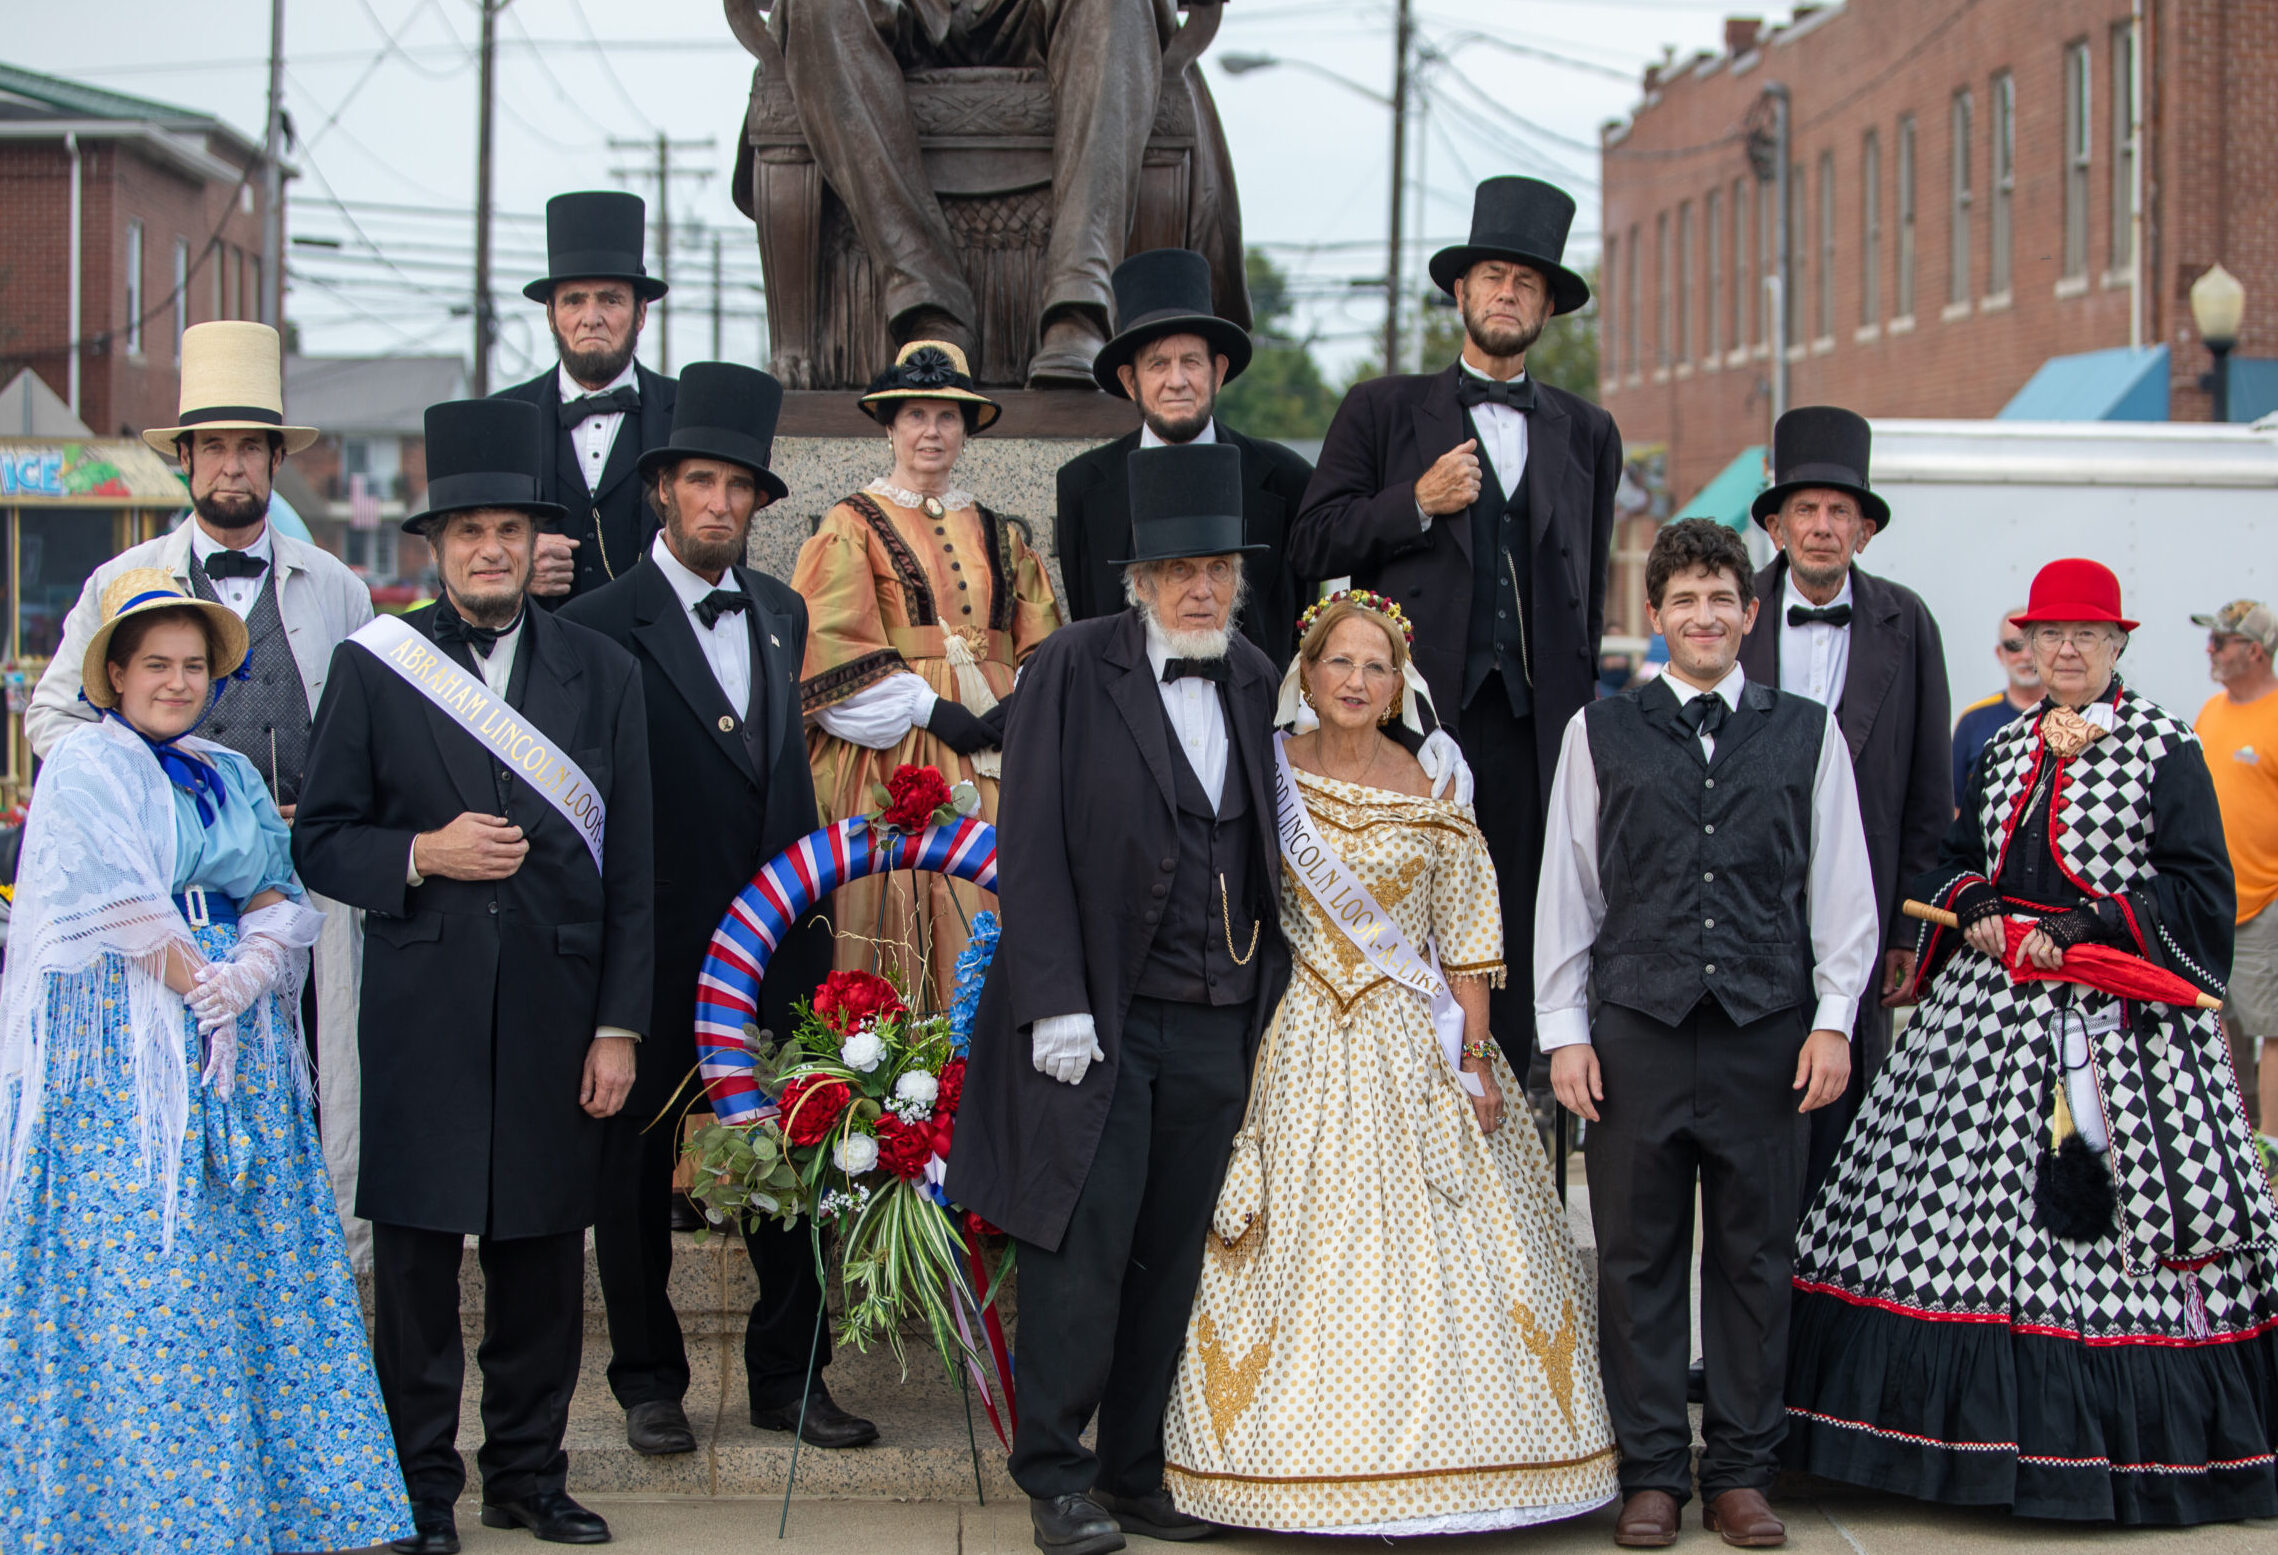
[292,398,656,1555]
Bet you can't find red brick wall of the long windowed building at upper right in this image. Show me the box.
[1601,0,2278,501]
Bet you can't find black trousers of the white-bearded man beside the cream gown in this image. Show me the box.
[1011,999,1251,1496]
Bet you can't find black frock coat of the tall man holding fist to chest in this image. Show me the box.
[1289,364,1622,804]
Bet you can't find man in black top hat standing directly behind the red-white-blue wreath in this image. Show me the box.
[560,362,877,1455]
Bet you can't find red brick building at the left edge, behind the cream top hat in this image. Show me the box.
[0,64,262,435]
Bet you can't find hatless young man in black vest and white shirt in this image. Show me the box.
[1535,519,1877,1548]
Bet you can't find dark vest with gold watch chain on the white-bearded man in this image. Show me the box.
[1132,692,1264,1004]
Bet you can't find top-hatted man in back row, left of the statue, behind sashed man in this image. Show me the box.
[497,189,674,603]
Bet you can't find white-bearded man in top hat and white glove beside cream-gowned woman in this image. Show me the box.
[948,444,1289,1555]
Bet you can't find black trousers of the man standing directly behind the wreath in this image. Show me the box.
[592,1111,831,1409]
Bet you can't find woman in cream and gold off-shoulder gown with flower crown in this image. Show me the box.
[1164,597,1617,1535]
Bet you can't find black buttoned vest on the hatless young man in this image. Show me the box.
[1583,681,1827,1025]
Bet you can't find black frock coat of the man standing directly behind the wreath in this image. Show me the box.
[560,558,831,1127]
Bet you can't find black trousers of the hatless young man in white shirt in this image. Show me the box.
[1583,999,1806,1503]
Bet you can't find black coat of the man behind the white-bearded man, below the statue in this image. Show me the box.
[1052,421,1314,669]
